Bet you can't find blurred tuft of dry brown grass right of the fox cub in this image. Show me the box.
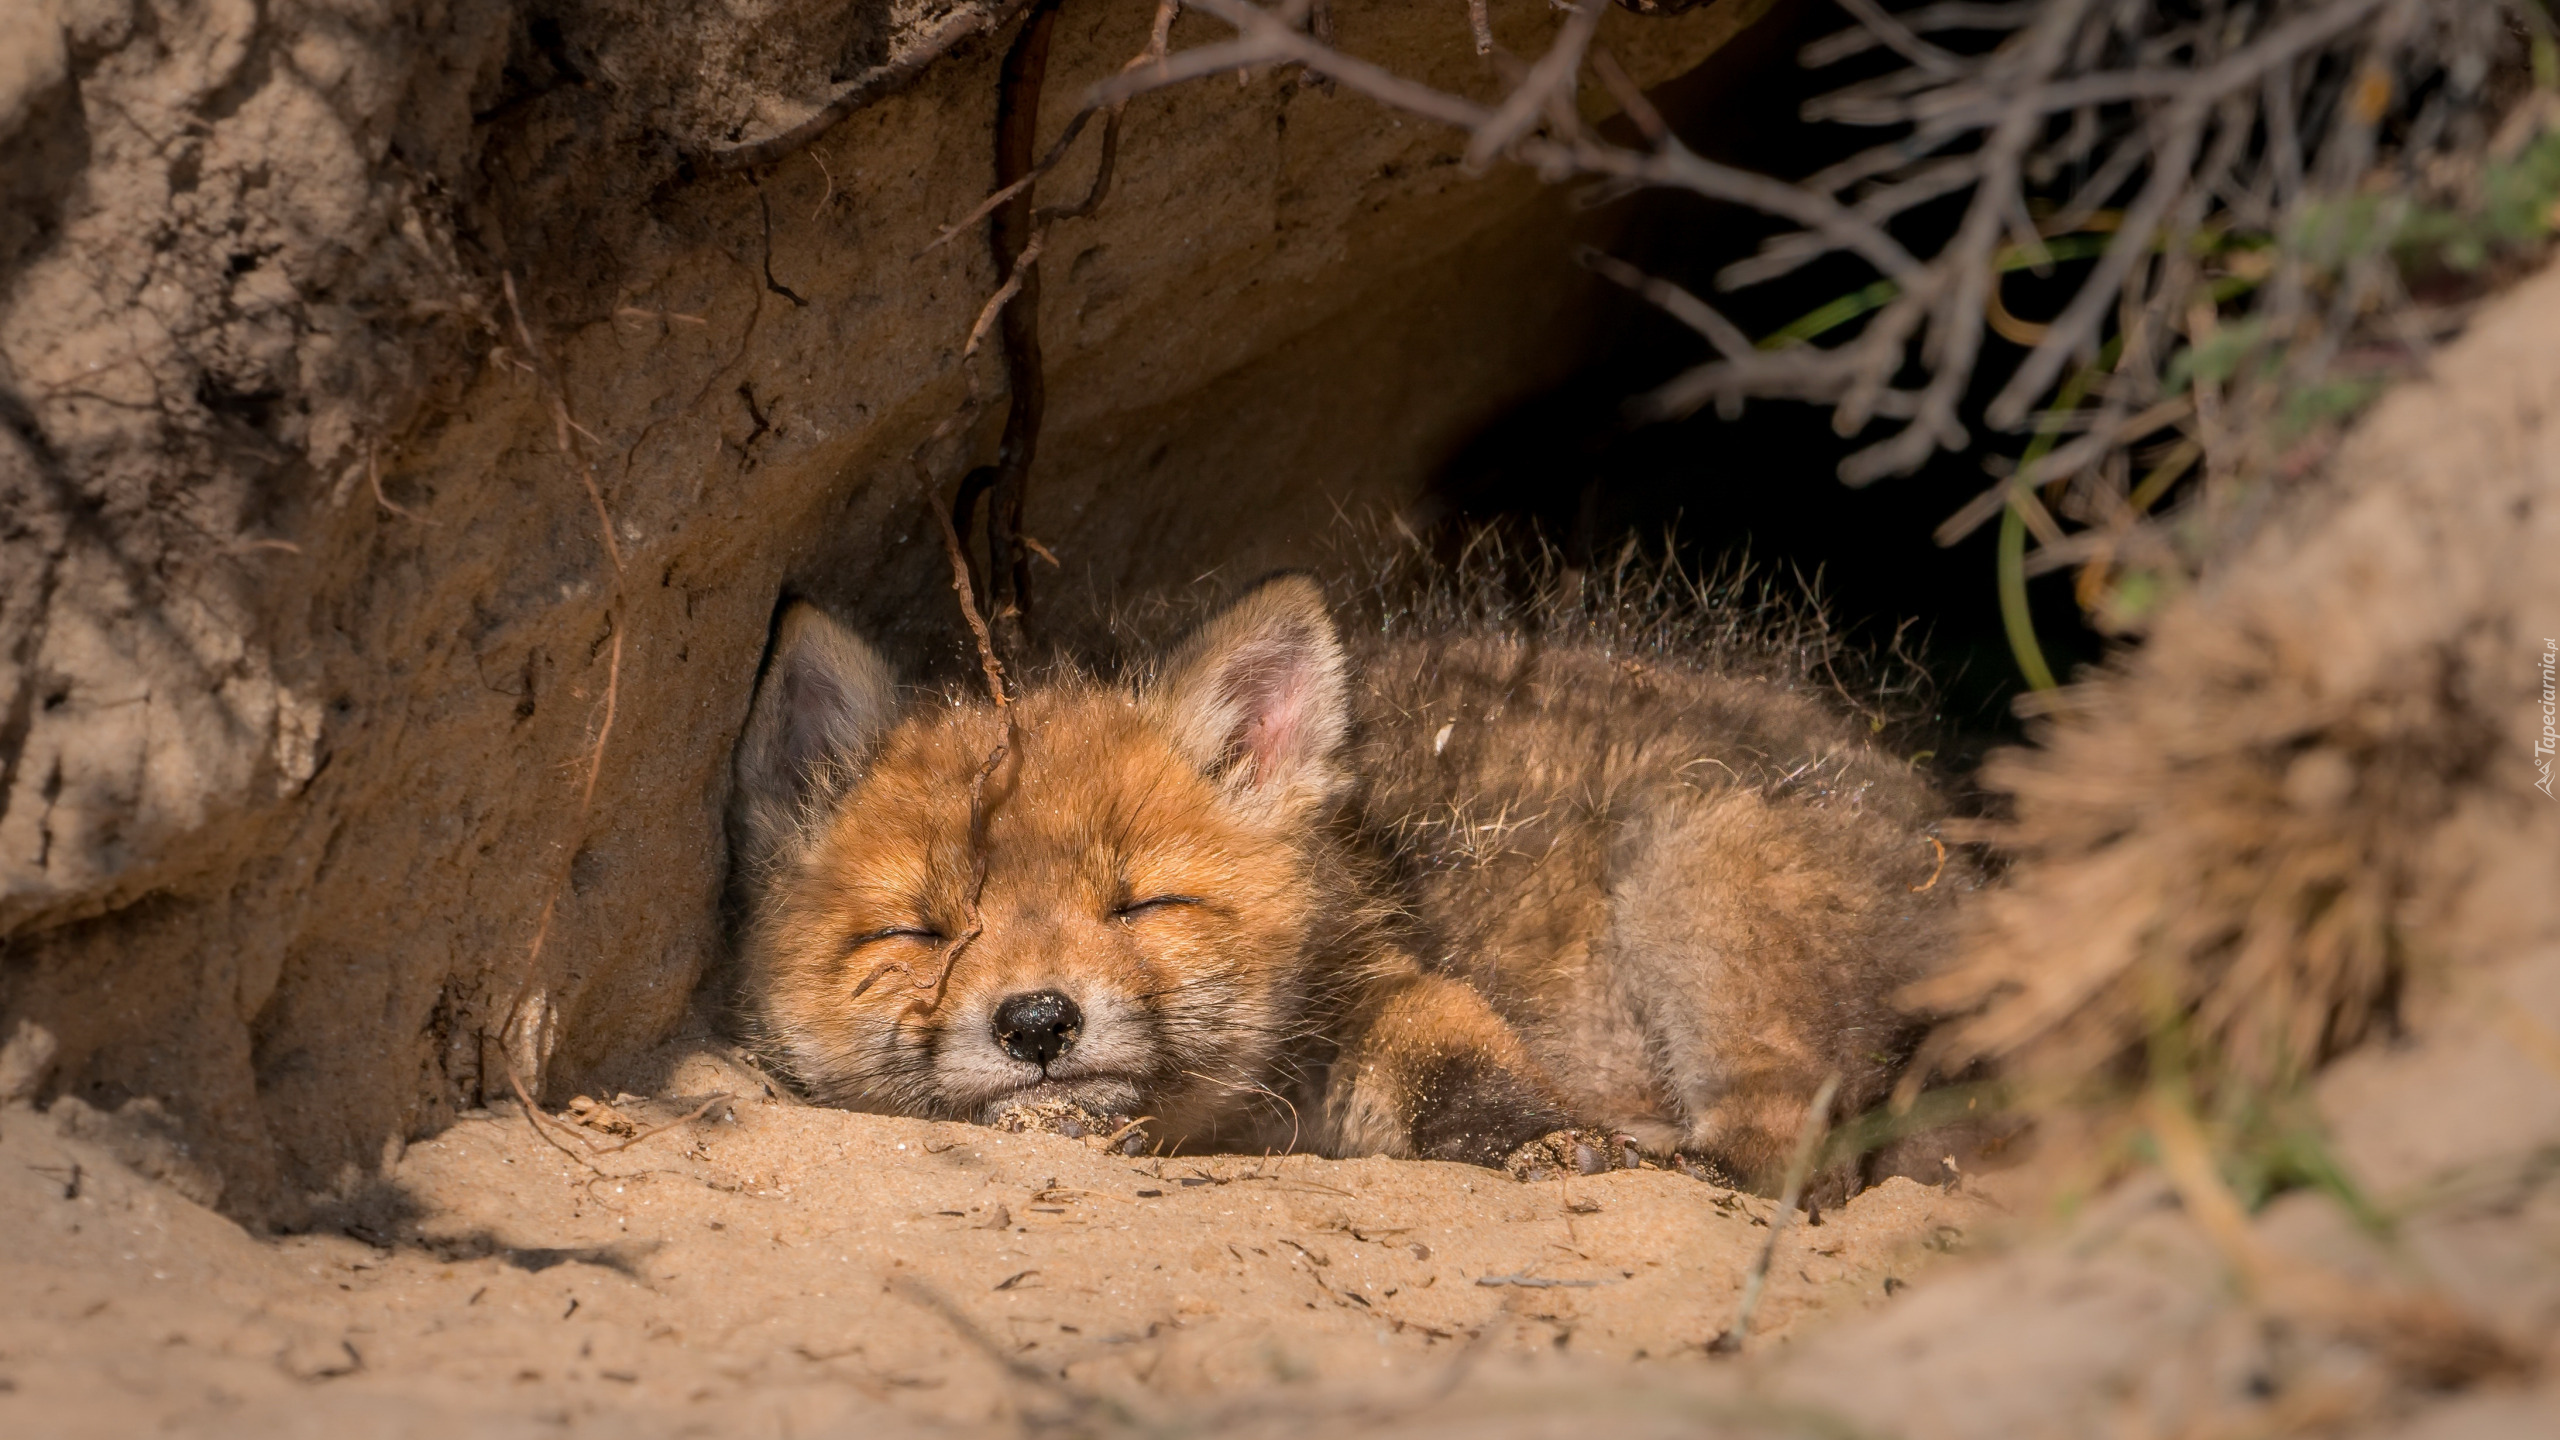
[1910,628,2488,1086]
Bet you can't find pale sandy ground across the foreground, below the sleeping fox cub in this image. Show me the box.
[0,945,2560,1440]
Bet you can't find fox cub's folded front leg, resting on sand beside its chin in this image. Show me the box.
[1326,958,1572,1166]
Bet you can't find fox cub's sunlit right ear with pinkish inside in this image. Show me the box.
[1147,574,1352,812]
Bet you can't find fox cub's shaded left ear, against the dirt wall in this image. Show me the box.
[735,602,899,856]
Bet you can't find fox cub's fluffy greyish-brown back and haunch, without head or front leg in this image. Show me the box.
[1357,630,1958,1176]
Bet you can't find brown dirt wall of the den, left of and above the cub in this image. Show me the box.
[0,0,1766,1222]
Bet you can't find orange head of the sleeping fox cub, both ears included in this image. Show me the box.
[737,577,1347,1135]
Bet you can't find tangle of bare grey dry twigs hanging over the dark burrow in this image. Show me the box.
[1085,0,2547,632]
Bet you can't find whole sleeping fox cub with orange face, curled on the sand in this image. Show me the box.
[737,577,1953,1186]
